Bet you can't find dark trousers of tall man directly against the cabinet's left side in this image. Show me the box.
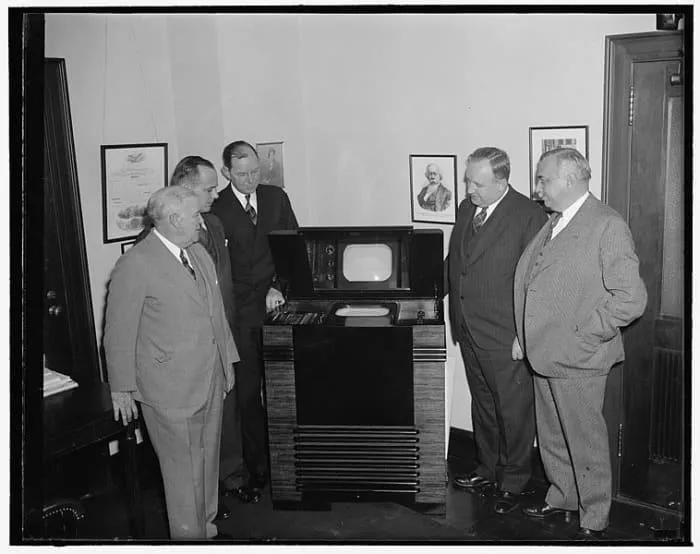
[234,327,267,475]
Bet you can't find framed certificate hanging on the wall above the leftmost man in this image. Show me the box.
[100,142,168,244]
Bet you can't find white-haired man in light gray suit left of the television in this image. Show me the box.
[104,186,239,539]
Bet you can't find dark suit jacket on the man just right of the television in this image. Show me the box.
[447,186,547,351]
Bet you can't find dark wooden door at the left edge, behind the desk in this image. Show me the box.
[43,59,101,383]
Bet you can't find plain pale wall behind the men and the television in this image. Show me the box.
[46,13,655,429]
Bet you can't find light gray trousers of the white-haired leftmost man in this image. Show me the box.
[141,362,224,540]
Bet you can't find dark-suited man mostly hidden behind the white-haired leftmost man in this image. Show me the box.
[136,156,260,504]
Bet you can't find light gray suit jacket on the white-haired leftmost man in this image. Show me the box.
[104,232,239,409]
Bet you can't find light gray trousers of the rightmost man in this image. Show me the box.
[535,375,612,531]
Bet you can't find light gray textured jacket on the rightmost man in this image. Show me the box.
[514,195,647,377]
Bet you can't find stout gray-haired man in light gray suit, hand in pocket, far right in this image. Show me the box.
[512,148,647,540]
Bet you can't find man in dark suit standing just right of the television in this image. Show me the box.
[448,147,546,514]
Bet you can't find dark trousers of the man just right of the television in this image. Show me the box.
[459,329,535,494]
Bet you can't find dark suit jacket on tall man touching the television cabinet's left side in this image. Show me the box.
[211,183,299,327]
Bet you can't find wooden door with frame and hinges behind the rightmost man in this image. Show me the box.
[603,32,690,514]
